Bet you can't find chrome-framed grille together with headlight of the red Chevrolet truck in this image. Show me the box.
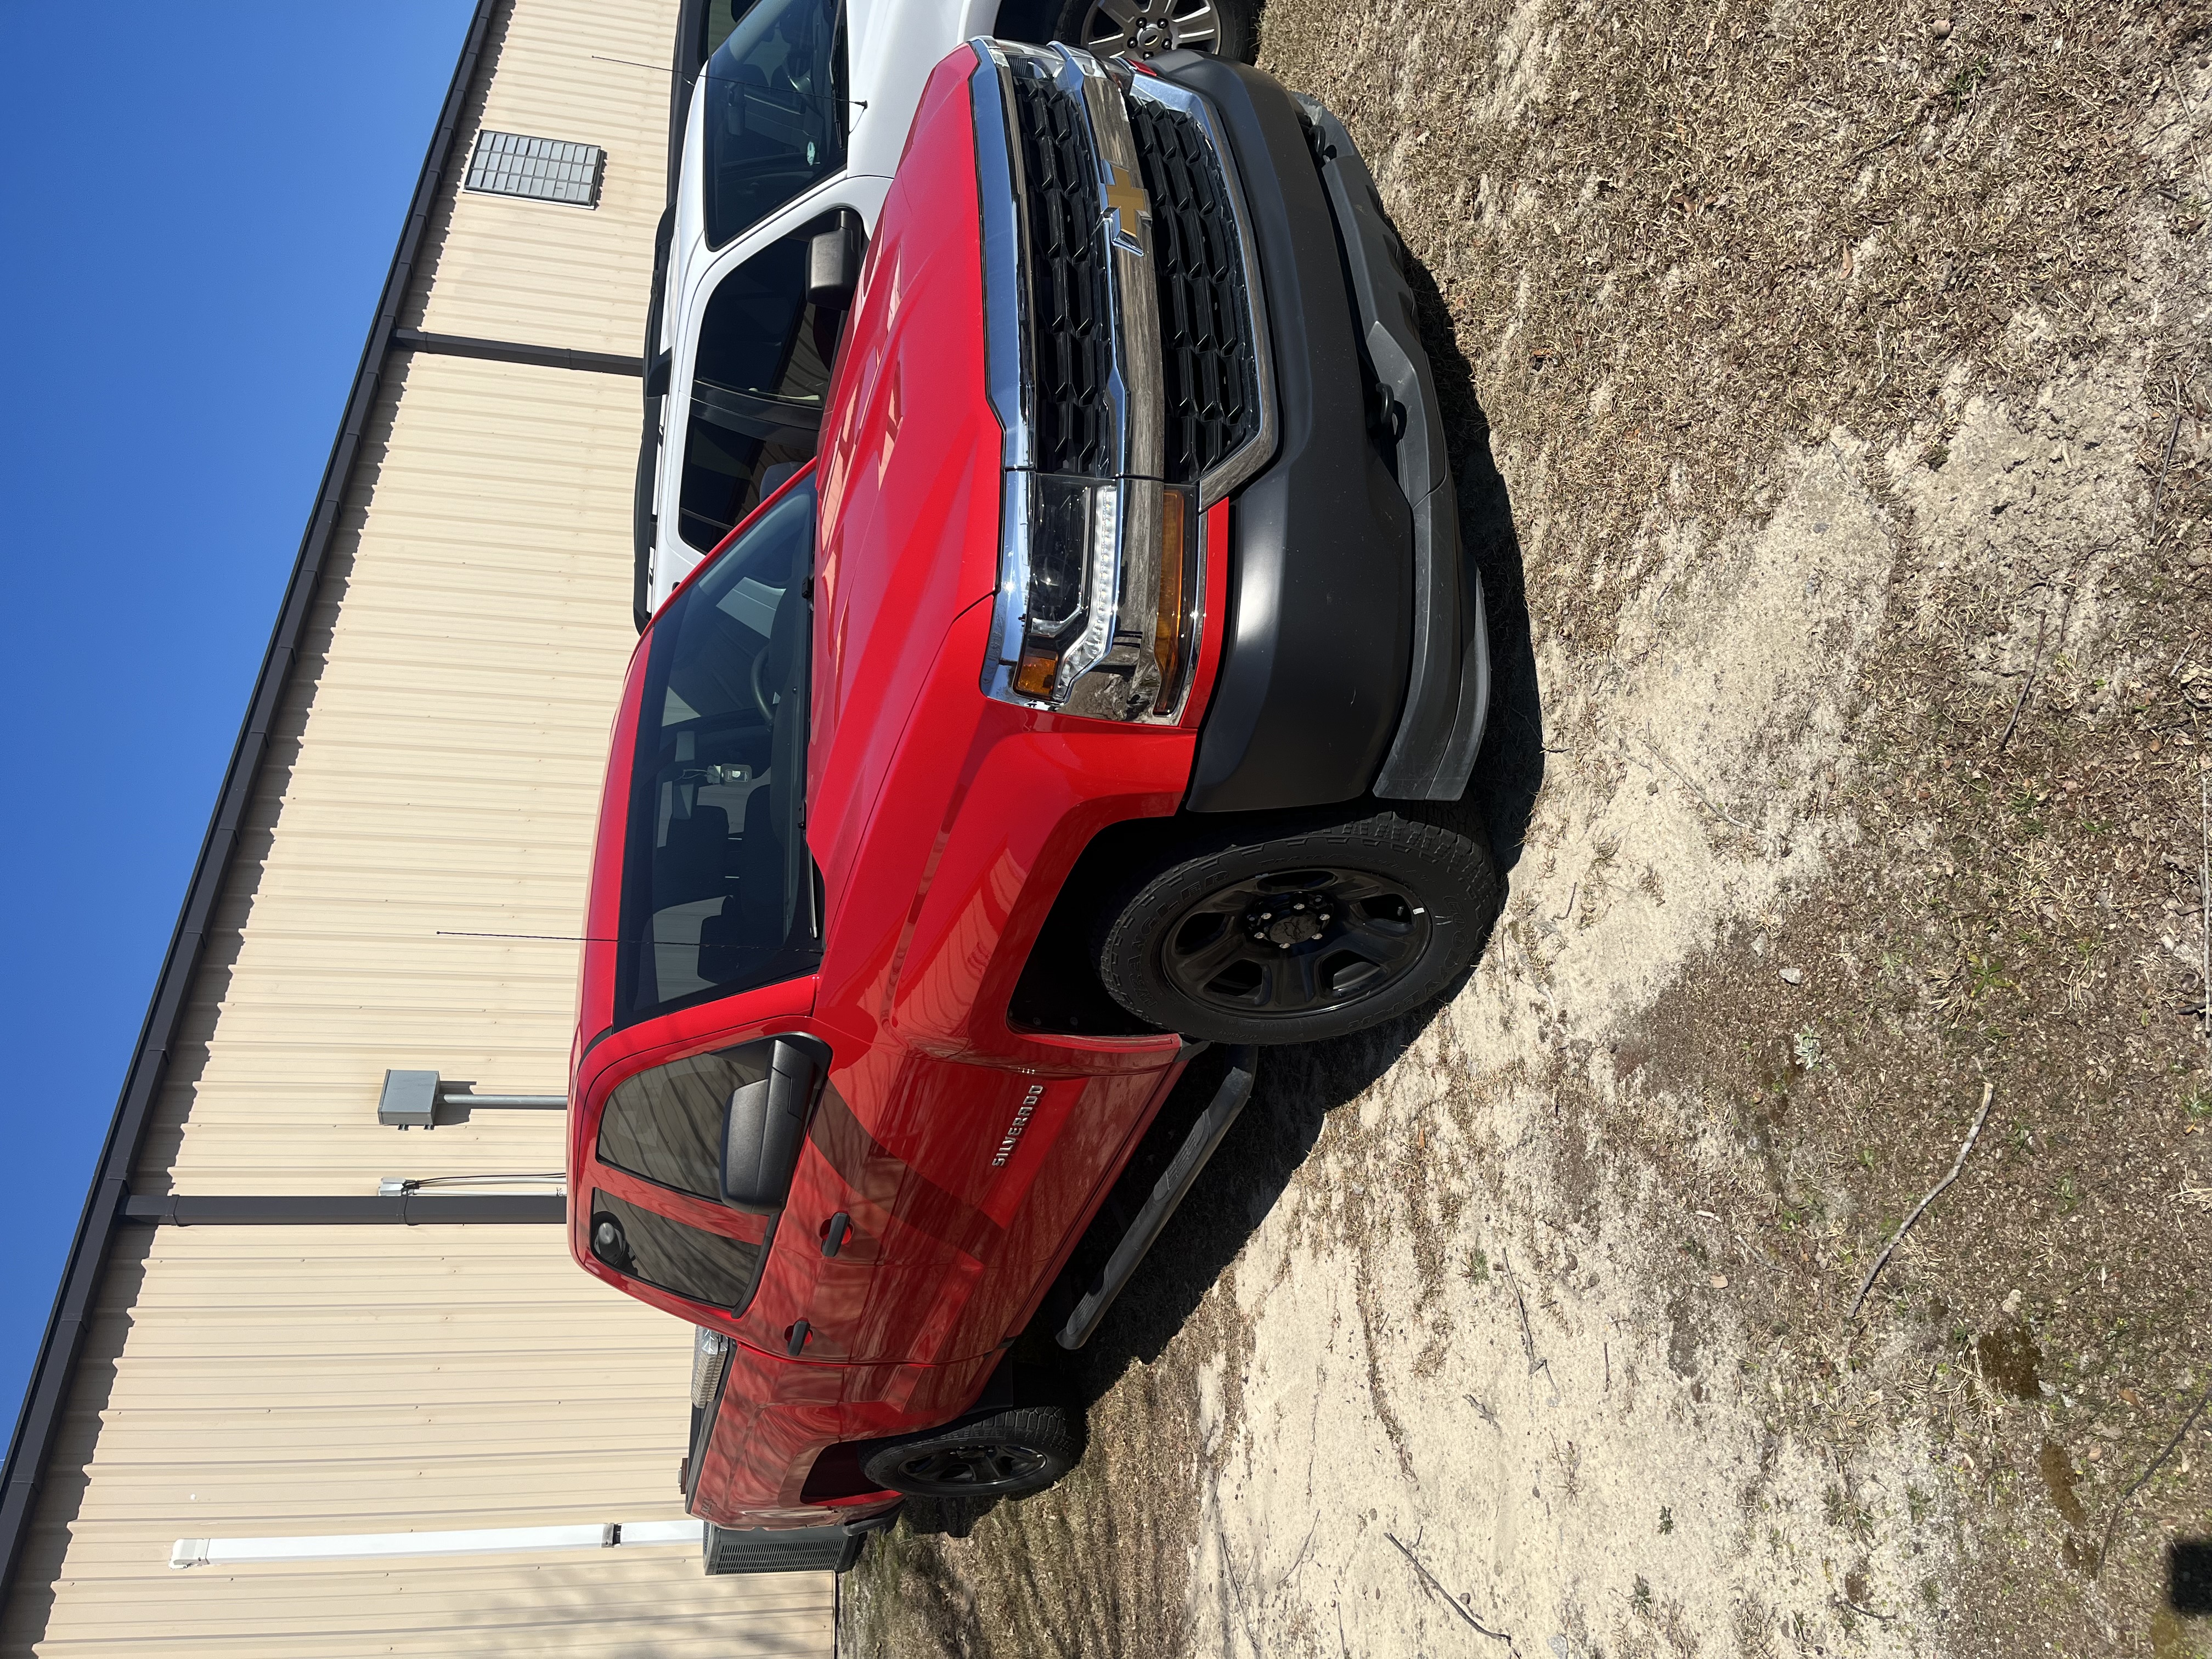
[969,40,1276,721]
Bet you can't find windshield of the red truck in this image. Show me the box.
[615,478,821,1024]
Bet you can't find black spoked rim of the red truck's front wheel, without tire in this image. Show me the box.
[1159,870,1431,1018]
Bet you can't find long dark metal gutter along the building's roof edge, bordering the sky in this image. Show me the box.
[0,0,498,1601]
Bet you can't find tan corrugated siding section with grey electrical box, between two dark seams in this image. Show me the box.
[137,352,637,1192]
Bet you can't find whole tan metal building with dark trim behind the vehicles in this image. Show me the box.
[0,0,834,1659]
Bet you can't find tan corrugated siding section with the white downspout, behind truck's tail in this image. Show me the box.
[9,1229,827,1657]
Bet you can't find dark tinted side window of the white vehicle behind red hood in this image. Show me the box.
[679,236,843,553]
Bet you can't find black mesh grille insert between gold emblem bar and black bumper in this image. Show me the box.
[1128,97,1259,484]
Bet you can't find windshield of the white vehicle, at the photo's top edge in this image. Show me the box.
[703,0,845,248]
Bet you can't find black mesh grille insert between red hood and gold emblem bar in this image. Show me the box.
[1013,75,1115,478]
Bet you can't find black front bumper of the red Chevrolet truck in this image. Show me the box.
[1153,53,1489,812]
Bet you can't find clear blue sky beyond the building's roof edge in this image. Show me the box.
[0,0,471,1425]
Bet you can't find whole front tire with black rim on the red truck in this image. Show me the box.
[1093,812,1498,1044]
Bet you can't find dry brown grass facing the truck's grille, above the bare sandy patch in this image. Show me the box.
[1265,0,2208,648]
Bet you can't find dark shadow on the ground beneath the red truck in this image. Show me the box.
[902,255,1546,1537]
